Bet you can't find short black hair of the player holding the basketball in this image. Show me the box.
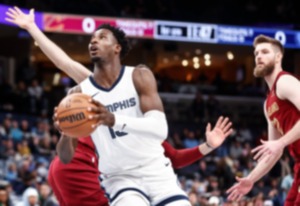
[96,24,131,59]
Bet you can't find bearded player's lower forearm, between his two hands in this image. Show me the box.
[247,150,282,183]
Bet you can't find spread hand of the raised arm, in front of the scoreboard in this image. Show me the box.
[5,6,34,29]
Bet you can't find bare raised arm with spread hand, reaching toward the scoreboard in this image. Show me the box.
[5,7,91,83]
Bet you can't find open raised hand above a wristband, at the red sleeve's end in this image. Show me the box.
[205,116,233,148]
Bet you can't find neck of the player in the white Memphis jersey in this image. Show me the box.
[94,62,122,88]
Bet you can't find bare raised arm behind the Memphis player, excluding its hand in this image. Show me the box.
[26,23,91,83]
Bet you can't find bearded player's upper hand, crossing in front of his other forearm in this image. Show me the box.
[251,139,284,162]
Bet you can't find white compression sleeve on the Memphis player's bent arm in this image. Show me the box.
[113,110,168,141]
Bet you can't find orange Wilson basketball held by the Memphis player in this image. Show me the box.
[57,93,97,137]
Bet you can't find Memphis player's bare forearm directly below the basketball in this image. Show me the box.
[56,135,77,164]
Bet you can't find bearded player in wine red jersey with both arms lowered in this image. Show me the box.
[227,35,300,206]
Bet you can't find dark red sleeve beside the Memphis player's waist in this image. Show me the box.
[162,141,203,169]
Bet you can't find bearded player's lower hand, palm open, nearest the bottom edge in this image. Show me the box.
[226,177,253,201]
